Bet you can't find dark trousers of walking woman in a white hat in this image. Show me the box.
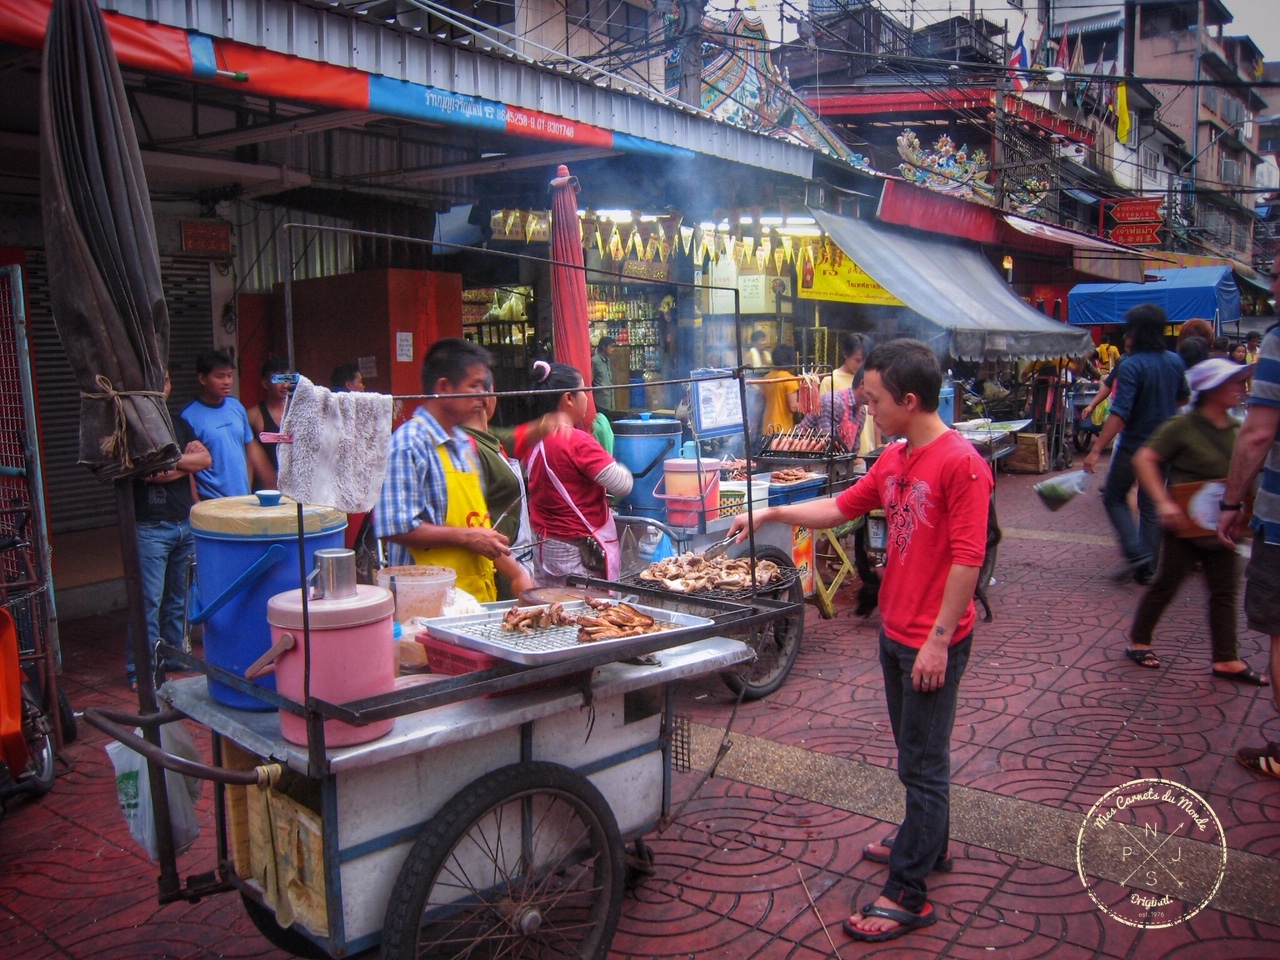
[1129,532,1239,663]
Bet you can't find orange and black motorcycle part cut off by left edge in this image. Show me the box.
[0,608,56,818]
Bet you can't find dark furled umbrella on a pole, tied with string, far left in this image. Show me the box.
[40,0,180,885]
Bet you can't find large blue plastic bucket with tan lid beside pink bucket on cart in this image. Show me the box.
[187,494,347,710]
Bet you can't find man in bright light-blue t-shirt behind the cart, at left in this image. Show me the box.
[182,349,265,500]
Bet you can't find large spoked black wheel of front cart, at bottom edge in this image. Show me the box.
[383,762,626,960]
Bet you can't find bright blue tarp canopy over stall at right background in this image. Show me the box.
[1066,266,1240,330]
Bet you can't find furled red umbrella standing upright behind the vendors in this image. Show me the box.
[552,164,595,428]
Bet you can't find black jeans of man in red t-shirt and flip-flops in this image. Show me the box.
[879,631,973,913]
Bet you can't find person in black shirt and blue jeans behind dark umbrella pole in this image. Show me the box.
[124,371,214,687]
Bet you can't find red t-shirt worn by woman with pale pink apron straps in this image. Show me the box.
[526,430,613,540]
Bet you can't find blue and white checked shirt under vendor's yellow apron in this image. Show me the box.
[374,407,479,567]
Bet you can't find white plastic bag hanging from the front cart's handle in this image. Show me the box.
[106,722,202,860]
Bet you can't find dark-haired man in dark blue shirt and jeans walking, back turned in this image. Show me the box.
[1084,303,1190,584]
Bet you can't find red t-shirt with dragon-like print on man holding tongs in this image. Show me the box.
[836,430,995,649]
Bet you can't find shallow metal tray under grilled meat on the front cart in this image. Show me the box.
[426,602,714,667]
